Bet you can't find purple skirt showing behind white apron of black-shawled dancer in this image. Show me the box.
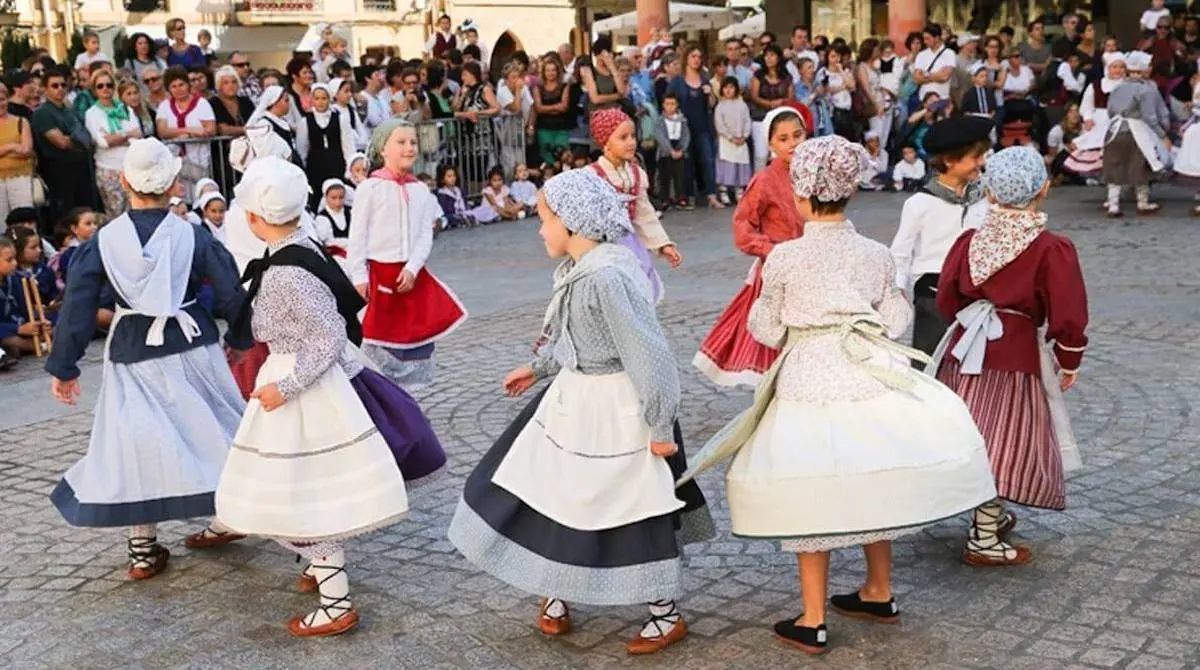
[350,367,446,481]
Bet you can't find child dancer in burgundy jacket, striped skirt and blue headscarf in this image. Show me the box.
[930,147,1094,566]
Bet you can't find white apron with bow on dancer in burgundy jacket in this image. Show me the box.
[925,302,1084,473]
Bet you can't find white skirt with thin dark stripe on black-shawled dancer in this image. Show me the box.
[216,353,408,543]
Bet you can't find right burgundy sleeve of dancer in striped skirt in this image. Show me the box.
[1037,235,1087,372]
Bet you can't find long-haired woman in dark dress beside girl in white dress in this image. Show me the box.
[667,44,725,209]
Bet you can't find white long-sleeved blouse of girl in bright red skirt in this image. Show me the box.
[347,178,442,286]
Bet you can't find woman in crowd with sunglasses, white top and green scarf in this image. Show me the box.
[84,70,142,220]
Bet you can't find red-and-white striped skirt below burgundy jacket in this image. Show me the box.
[937,357,1067,509]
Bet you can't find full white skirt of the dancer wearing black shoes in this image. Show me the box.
[714,379,996,551]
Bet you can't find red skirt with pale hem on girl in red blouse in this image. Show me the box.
[691,262,779,387]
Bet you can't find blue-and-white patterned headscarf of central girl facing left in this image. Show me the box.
[541,169,634,241]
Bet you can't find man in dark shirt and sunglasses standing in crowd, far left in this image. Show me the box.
[30,68,96,220]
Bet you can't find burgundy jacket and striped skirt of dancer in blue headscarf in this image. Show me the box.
[937,223,1087,509]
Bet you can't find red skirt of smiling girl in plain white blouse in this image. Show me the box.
[362,261,467,349]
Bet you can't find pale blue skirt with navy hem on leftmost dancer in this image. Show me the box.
[50,345,246,527]
